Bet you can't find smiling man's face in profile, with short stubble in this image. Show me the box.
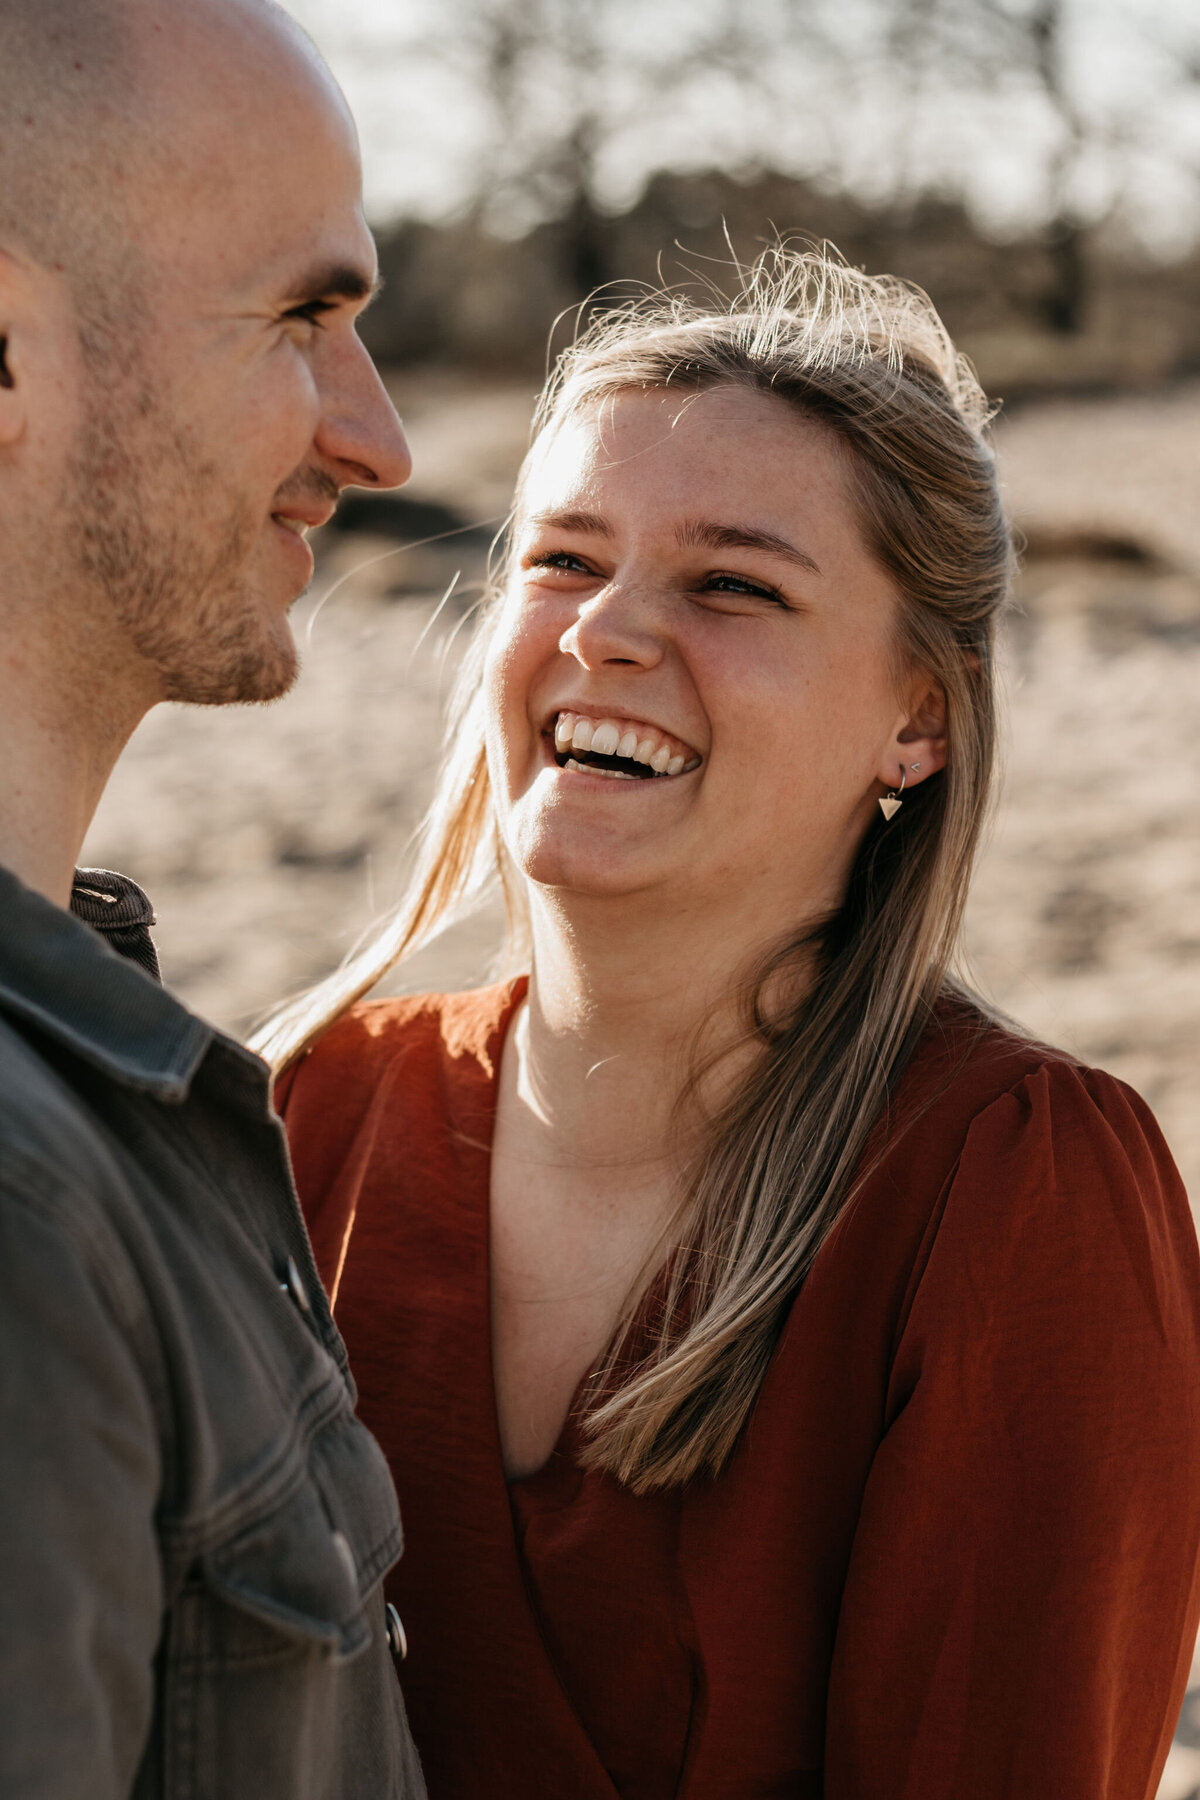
[70,7,410,704]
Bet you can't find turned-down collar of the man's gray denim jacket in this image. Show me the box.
[0,868,216,1100]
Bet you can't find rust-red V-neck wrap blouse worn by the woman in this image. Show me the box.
[279,985,1200,1800]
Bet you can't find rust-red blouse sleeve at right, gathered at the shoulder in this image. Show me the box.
[824,1064,1200,1800]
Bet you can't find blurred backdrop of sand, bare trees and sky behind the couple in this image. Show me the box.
[86,0,1200,1800]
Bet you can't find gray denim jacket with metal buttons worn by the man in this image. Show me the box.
[0,869,425,1800]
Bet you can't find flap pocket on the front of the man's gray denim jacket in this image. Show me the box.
[162,1411,405,1800]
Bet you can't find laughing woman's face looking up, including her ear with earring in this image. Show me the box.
[486,387,941,932]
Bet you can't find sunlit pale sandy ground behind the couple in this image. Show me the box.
[86,361,1200,1800]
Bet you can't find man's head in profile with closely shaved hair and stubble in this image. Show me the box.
[0,0,408,704]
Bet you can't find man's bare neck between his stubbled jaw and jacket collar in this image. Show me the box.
[0,635,142,905]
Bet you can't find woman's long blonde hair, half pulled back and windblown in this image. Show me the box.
[257,245,1011,1492]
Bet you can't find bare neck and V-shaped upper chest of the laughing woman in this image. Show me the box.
[489,896,759,1476]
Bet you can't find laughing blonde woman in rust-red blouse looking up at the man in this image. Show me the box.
[266,250,1200,1800]
